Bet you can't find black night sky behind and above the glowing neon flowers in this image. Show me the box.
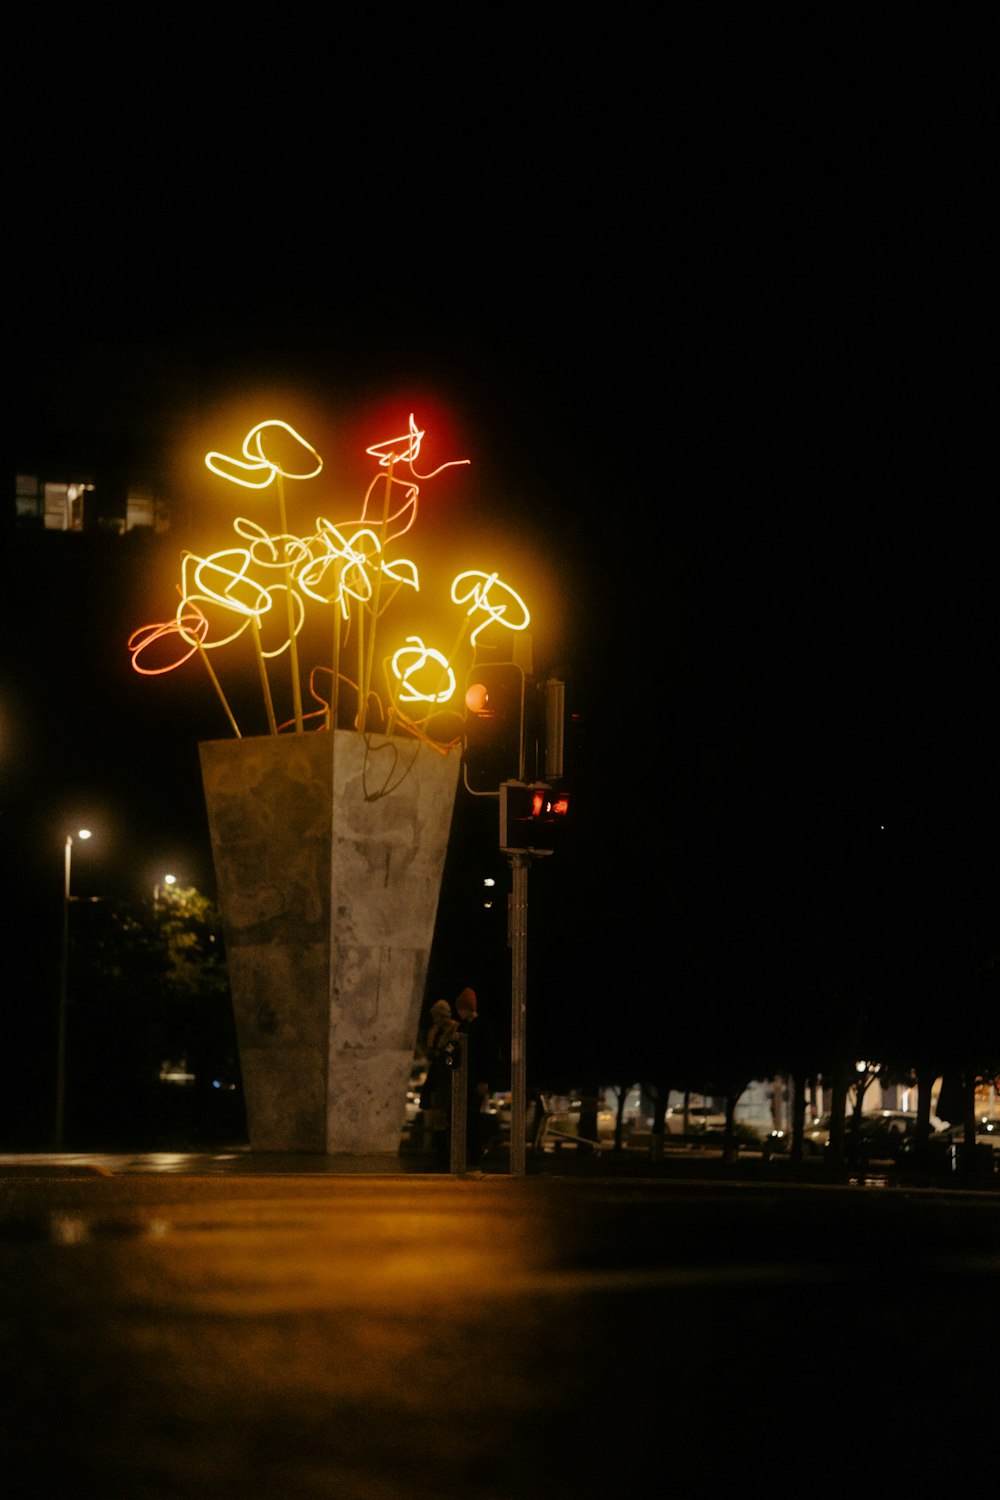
[3,12,1000,1116]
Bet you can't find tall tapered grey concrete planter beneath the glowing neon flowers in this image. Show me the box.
[199,731,459,1154]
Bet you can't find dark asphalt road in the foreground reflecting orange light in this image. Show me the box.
[0,1166,1000,1500]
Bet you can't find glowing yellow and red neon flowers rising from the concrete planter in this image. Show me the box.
[127,413,529,750]
